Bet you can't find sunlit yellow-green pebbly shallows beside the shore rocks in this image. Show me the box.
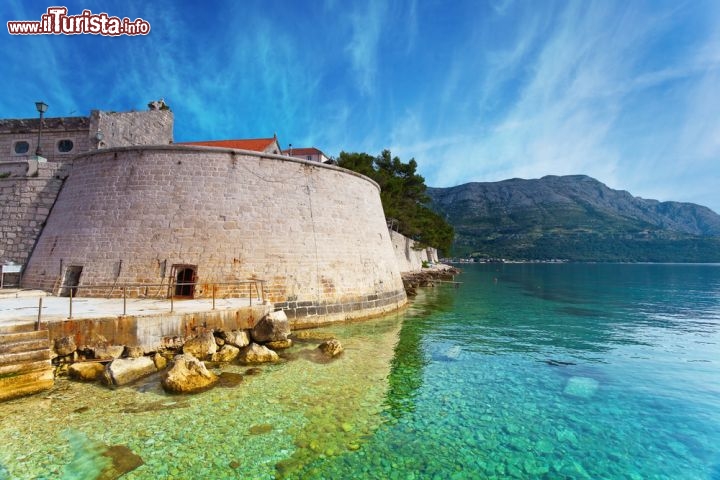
[0,315,401,480]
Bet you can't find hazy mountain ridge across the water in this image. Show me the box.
[427,175,720,262]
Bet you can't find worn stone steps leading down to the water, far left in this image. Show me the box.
[0,324,55,401]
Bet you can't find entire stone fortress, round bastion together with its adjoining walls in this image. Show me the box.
[0,108,437,326]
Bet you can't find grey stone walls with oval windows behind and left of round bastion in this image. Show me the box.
[0,110,173,284]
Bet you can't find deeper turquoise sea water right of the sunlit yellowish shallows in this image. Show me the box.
[292,264,720,480]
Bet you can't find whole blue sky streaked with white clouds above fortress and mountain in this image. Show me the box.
[0,0,720,212]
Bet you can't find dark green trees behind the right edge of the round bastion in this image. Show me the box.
[337,150,455,254]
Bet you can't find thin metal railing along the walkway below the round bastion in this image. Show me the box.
[55,279,265,318]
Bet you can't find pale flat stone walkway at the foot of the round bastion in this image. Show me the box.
[0,288,261,326]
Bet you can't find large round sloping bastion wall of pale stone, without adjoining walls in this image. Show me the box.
[23,146,407,326]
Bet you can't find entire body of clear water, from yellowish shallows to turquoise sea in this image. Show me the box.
[0,264,720,480]
